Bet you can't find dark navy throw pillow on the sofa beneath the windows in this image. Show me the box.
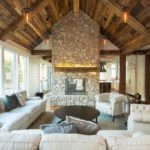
[4,94,18,111]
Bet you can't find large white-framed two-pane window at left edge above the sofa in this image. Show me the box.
[0,46,28,95]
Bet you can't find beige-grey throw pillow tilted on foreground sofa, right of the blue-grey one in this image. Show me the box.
[66,116,100,135]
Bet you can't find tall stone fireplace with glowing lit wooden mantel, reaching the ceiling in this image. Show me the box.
[51,11,100,106]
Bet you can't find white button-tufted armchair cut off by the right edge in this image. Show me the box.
[128,104,150,133]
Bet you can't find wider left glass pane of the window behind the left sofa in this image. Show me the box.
[4,50,15,94]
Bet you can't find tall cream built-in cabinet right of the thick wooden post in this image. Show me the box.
[126,55,145,100]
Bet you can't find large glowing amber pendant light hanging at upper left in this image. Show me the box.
[24,0,32,23]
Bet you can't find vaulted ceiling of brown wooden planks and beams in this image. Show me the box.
[0,0,150,54]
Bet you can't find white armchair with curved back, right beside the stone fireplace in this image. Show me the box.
[95,93,127,121]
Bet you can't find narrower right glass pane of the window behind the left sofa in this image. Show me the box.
[18,56,27,90]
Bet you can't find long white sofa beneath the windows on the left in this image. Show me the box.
[0,91,46,131]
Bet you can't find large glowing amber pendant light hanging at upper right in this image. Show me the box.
[122,0,129,23]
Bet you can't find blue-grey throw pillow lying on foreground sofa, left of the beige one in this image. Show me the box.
[40,123,77,134]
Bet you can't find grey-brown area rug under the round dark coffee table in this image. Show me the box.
[29,112,127,130]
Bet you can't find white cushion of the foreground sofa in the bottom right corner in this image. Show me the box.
[106,135,150,150]
